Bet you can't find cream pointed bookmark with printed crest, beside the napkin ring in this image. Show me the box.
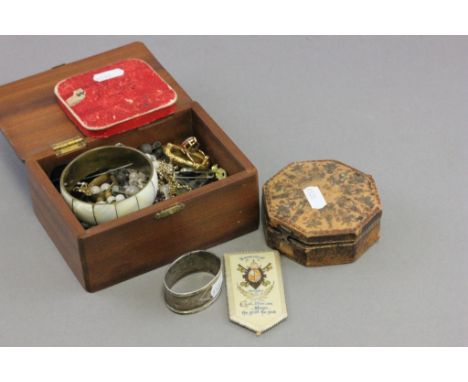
[224,251,288,335]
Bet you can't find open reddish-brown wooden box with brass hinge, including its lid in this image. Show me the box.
[0,42,259,292]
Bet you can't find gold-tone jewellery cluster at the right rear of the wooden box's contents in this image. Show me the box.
[163,137,210,170]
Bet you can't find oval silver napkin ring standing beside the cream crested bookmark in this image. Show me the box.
[164,251,223,314]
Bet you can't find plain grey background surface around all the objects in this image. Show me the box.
[0,37,468,346]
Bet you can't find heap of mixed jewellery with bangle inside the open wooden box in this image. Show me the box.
[50,136,227,228]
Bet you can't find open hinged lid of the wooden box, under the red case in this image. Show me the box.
[0,42,192,160]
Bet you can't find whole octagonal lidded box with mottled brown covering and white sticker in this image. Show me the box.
[263,160,382,267]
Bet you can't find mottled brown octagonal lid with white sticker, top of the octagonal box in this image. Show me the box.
[263,160,382,245]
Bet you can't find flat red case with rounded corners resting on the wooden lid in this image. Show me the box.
[55,59,177,137]
